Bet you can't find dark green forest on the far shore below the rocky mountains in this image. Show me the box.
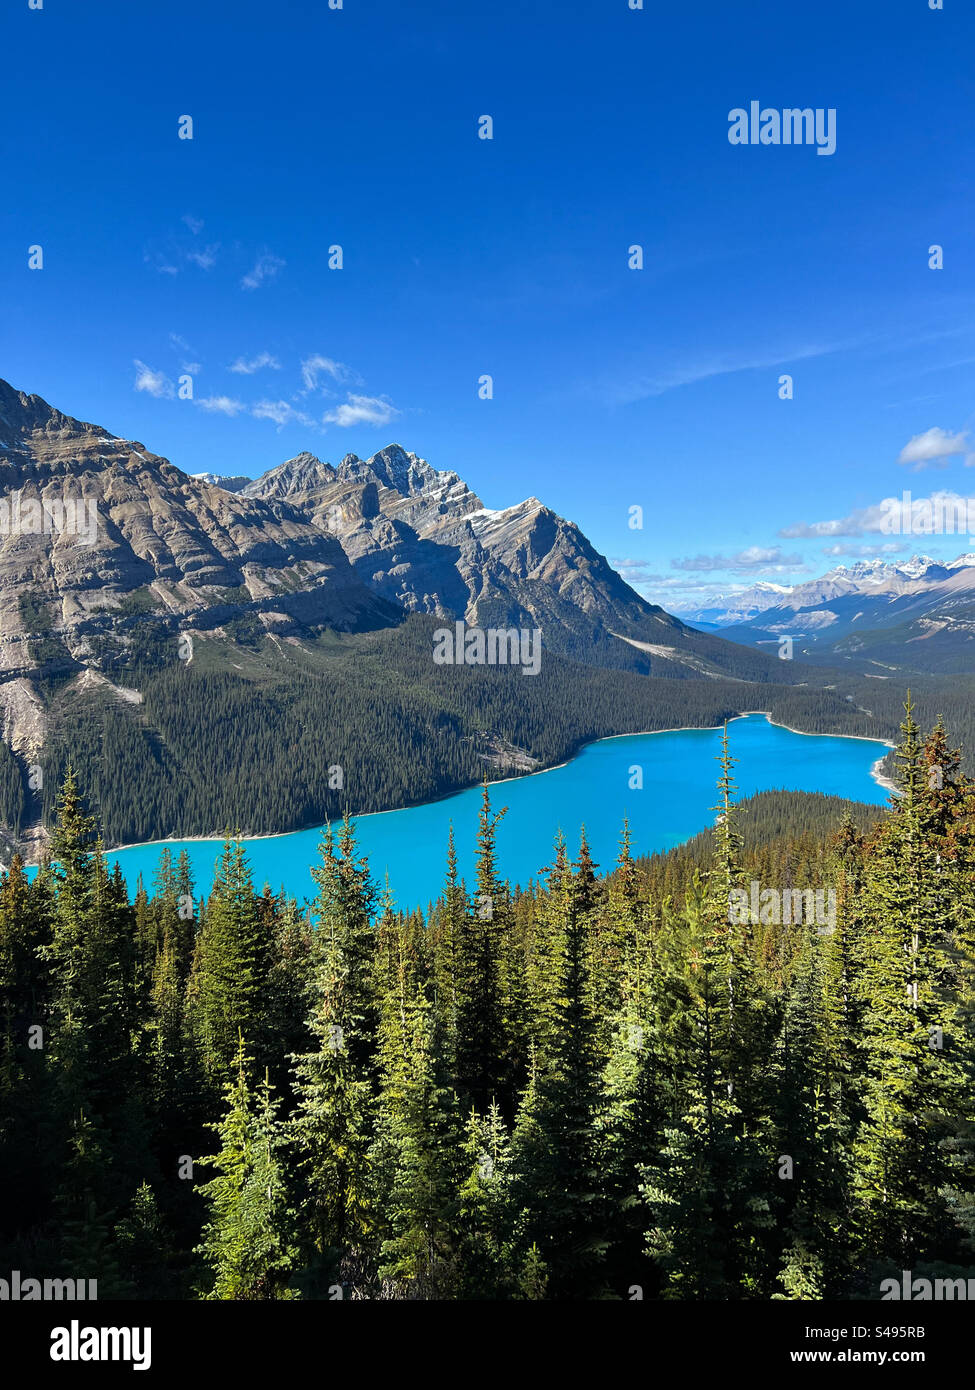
[15,617,975,845]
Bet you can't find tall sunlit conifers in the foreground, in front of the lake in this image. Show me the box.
[0,703,975,1300]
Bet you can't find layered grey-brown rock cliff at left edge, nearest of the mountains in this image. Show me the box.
[0,381,401,689]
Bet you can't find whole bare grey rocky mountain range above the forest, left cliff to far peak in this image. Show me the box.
[0,381,784,800]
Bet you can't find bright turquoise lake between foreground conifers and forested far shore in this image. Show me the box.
[100,714,889,908]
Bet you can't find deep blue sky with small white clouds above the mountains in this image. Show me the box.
[0,0,975,609]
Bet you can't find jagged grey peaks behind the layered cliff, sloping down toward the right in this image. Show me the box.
[245,445,680,655]
